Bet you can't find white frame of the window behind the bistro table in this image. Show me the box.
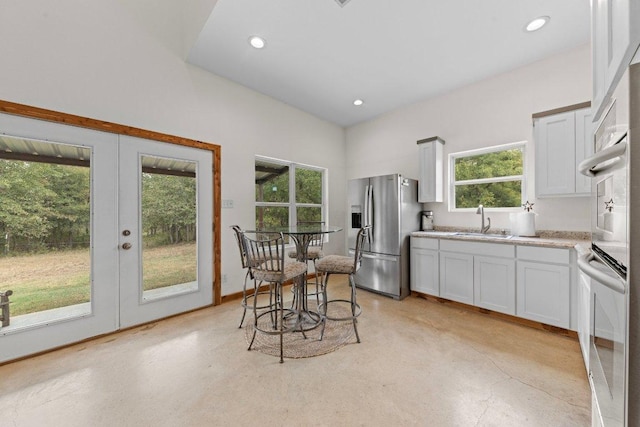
[253,155,329,234]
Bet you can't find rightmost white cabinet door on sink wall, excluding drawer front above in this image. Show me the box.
[516,261,571,329]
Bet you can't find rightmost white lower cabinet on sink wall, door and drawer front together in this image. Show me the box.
[516,246,571,329]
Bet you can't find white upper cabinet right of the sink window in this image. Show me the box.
[534,107,593,201]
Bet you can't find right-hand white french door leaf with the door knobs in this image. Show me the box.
[119,136,213,327]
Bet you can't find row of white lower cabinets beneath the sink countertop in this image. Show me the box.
[411,237,576,330]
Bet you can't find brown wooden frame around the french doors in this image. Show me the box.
[0,100,222,305]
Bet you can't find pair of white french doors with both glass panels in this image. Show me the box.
[0,114,213,362]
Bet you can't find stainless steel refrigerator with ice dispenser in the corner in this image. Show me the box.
[347,174,422,299]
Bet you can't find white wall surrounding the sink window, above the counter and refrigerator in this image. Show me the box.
[347,46,591,231]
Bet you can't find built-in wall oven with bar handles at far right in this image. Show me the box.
[578,92,629,427]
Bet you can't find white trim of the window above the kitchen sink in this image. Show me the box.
[448,141,527,212]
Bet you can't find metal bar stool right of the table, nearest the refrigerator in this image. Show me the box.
[316,225,371,342]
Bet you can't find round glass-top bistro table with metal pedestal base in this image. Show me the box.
[259,223,342,332]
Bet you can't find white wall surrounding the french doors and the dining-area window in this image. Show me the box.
[0,0,346,295]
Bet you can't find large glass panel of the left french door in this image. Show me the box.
[0,140,91,328]
